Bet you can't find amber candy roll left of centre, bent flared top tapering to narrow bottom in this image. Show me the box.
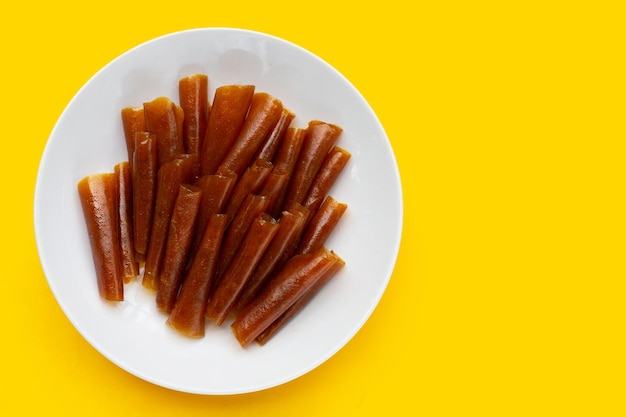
[141,155,197,290]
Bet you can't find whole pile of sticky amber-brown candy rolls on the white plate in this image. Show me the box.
[78,74,351,347]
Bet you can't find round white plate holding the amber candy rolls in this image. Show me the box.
[35,28,403,394]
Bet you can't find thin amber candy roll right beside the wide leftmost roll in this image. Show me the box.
[113,161,139,283]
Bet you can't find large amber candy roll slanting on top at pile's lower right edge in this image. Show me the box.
[231,248,335,347]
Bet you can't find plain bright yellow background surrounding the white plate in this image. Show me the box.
[0,0,626,416]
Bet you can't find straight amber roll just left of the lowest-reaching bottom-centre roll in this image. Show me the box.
[156,184,202,313]
